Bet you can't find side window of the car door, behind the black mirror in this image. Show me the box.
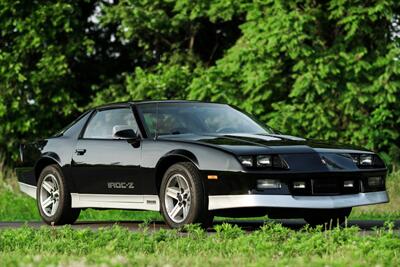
[83,108,138,139]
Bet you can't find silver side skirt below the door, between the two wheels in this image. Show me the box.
[71,193,160,211]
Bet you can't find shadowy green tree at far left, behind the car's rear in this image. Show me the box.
[0,0,126,160]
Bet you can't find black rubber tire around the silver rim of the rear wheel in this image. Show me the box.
[36,165,81,225]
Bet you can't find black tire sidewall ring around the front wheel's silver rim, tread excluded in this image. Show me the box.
[160,163,204,228]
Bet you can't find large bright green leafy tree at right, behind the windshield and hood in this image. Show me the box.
[190,1,400,166]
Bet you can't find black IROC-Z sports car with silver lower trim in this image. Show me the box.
[17,101,388,227]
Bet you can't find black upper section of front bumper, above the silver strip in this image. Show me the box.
[203,169,386,196]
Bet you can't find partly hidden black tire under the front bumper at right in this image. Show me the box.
[304,208,351,228]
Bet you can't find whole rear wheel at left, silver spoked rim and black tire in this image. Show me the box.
[36,165,80,225]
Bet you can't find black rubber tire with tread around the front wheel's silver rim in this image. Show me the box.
[160,162,213,229]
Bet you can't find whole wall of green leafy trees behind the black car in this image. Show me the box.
[0,0,400,168]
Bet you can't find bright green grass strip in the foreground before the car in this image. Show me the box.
[0,223,400,266]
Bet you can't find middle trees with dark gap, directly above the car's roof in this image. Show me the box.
[94,0,245,104]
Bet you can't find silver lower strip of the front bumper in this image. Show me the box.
[208,191,389,210]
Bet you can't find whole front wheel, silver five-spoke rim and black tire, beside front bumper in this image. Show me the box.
[160,162,213,228]
